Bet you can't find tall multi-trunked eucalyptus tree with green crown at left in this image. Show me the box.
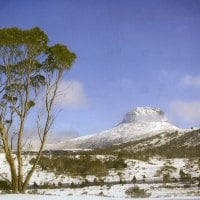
[0,27,76,193]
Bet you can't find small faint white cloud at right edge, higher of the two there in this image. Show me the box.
[180,75,200,88]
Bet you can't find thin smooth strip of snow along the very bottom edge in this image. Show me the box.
[0,195,200,200]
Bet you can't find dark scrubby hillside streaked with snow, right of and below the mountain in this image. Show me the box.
[96,129,200,159]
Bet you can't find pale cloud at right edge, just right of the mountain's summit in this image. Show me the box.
[171,100,200,124]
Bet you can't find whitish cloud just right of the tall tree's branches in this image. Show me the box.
[56,81,88,107]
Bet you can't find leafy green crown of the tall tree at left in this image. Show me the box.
[0,27,76,114]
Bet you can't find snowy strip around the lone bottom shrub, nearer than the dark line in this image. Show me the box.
[22,184,200,199]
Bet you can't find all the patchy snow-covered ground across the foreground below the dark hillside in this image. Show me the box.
[0,154,200,200]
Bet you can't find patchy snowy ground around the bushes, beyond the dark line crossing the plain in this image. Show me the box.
[0,153,200,185]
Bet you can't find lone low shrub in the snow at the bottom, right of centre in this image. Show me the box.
[125,185,151,198]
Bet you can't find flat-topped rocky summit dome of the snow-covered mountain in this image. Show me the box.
[121,107,168,123]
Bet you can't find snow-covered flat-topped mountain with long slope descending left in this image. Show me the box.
[47,107,182,150]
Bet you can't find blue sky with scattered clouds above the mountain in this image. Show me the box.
[0,0,200,135]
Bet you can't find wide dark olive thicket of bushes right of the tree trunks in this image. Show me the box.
[30,155,127,177]
